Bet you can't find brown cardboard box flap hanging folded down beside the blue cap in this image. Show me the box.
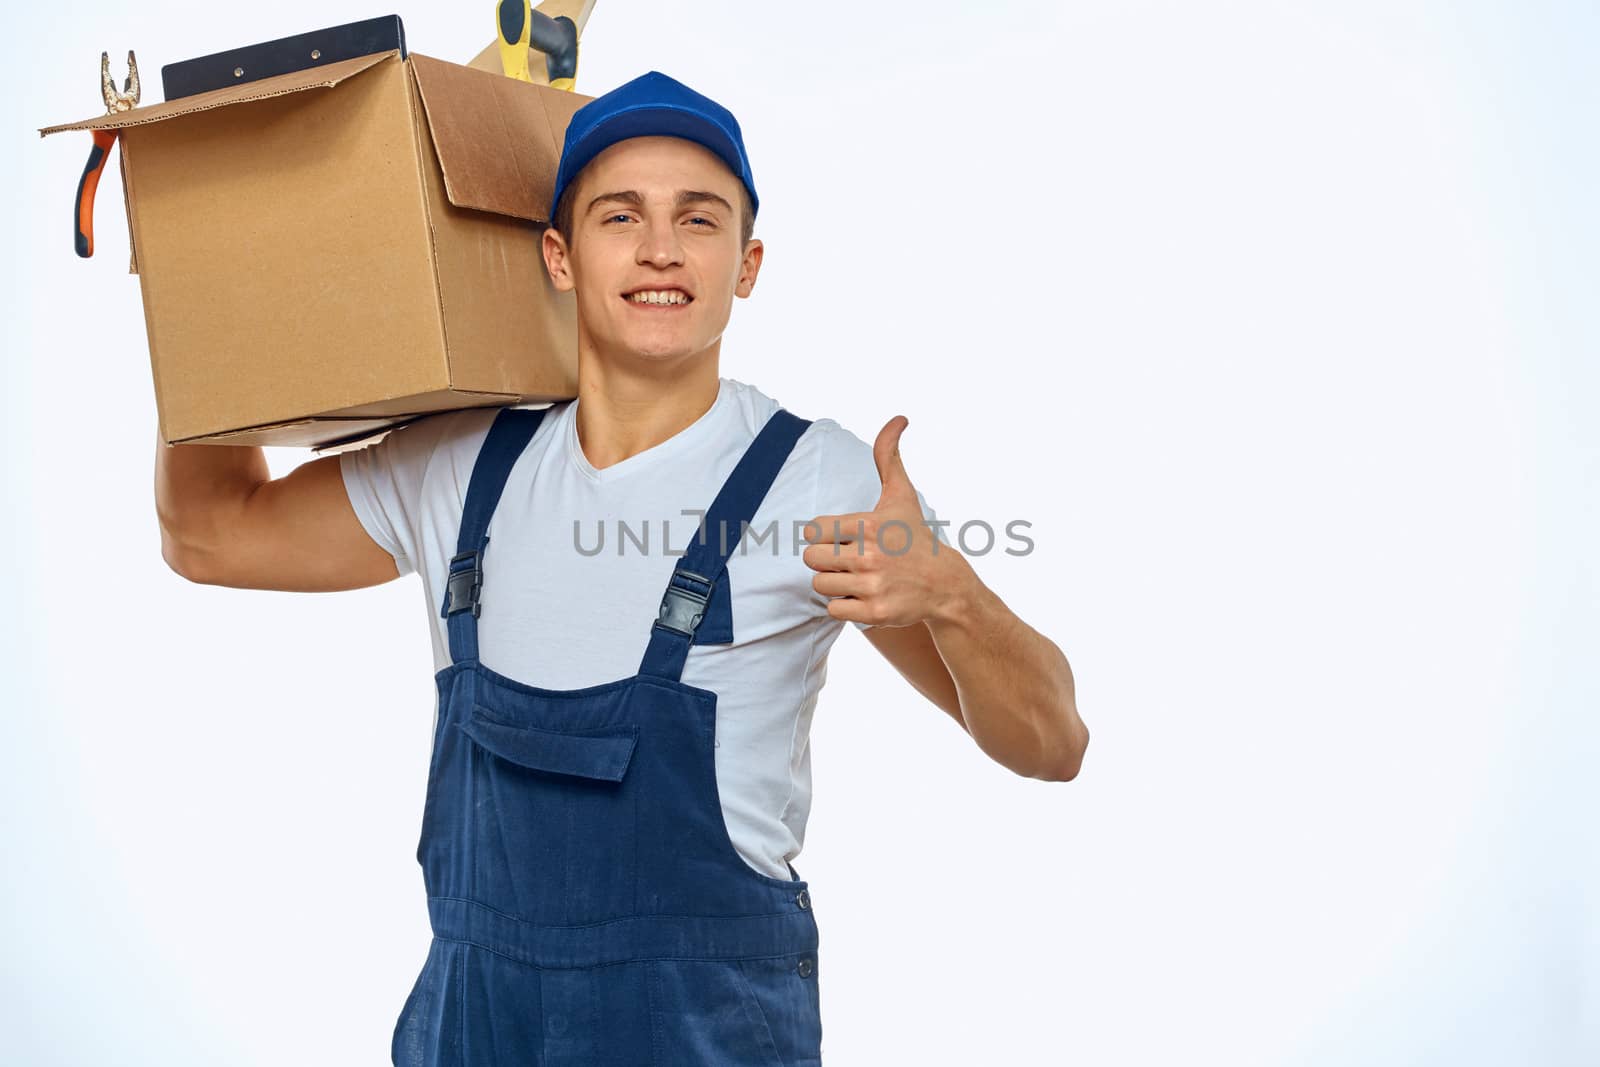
[410,51,594,222]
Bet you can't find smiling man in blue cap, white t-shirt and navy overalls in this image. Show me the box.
[157,72,1088,1067]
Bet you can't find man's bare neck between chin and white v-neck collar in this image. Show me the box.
[578,346,720,470]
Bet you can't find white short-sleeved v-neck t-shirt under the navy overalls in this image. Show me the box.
[339,378,947,878]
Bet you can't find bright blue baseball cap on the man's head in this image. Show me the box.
[550,70,760,230]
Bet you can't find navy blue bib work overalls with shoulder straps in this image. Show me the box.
[390,408,822,1067]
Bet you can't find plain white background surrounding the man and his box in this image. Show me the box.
[0,0,1600,1067]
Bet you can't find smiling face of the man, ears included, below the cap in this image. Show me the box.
[544,138,762,369]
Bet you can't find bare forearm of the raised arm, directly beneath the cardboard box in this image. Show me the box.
[155,432,272,574]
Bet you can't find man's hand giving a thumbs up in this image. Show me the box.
[802,414,973,625]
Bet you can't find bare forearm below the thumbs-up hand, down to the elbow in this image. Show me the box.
[926,558,1088,781]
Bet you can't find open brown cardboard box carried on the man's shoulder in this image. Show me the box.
[40,51,590,448]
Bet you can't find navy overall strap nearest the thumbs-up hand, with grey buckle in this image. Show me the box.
[638,408,811,681]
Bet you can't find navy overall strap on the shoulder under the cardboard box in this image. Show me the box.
[440,408,549,664]
